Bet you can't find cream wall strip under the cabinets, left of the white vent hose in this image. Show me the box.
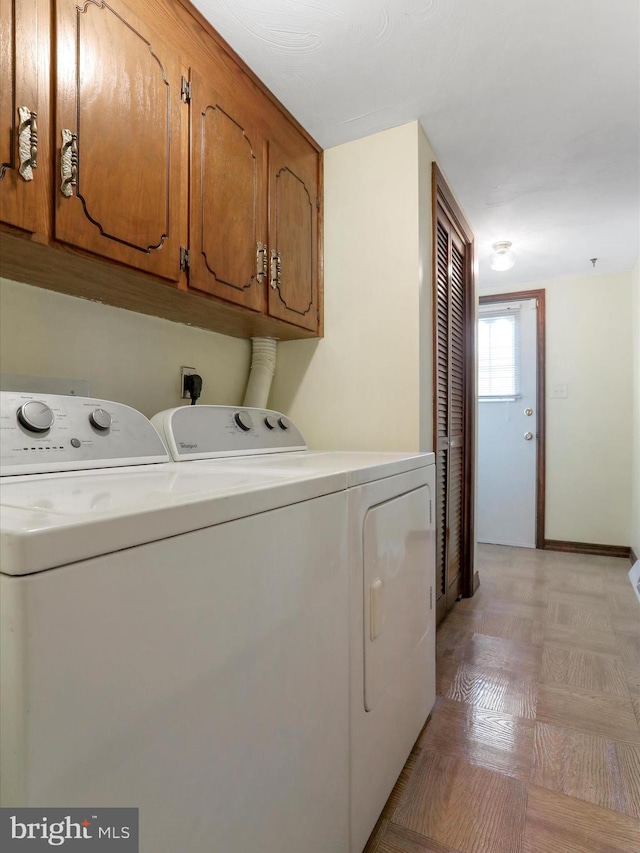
[0,279,250,416]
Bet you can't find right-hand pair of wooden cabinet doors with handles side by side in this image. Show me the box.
[189,71,319,332]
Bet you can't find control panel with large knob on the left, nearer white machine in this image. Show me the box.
[0,391,170,477]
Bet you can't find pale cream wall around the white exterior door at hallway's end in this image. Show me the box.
[480,273,632,546]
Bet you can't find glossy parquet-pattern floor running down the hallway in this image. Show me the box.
[365,545,640,853]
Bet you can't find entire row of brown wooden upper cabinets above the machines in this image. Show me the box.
[0,0,323,340]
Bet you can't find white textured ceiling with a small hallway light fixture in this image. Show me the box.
[195,0,640,287]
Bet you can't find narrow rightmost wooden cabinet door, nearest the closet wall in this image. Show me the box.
[269,139,318,331]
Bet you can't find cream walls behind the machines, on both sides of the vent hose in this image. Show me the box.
[0,122,434,451]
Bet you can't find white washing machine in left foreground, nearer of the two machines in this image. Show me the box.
[0,393,349,853]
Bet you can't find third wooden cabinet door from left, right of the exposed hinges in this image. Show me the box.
[189,72,268,312]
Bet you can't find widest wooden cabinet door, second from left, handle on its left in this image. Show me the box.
[55,0,181,280]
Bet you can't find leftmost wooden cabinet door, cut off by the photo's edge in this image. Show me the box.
[0,0,50,232]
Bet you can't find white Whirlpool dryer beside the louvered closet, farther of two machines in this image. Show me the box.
[152,406,435,853]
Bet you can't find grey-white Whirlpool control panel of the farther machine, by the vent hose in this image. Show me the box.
[151,405,307,462]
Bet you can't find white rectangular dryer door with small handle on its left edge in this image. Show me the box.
[363,486,431,711]
